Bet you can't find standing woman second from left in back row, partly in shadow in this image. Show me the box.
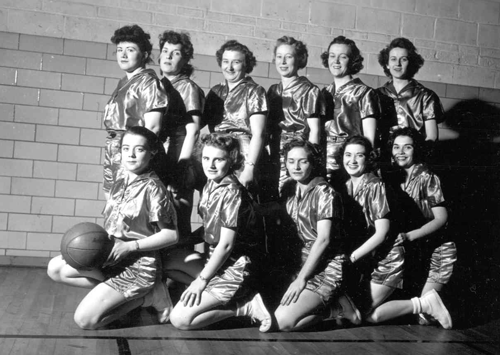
[159,31,205,236]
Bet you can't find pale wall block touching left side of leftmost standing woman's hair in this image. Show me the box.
[64,16,120,43]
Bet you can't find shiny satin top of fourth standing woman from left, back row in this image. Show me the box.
[267,76,326,139]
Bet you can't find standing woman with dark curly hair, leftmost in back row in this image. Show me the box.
[103,25,168,197]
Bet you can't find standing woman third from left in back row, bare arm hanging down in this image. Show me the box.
[203,40,268,191]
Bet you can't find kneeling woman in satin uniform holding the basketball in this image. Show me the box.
[47,126,178,329]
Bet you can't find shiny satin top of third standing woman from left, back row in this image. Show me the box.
[203,76,268,135]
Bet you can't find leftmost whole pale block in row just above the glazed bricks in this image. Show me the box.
[9,10,64,38]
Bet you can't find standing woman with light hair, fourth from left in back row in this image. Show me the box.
[267,36,325,195]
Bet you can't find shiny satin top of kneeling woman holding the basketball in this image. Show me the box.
[103,171,177,240]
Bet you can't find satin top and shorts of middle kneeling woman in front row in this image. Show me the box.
[282,177,345,303]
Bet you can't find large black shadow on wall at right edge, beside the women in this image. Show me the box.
[433,100,500,328]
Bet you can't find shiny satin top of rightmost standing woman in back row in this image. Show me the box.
[377,79,444,136]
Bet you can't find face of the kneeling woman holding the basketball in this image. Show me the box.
[122,133,153,175]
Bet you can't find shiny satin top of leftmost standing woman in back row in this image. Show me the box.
[104,69,168,131]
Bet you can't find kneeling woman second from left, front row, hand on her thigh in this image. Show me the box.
[165,133,271,332]
